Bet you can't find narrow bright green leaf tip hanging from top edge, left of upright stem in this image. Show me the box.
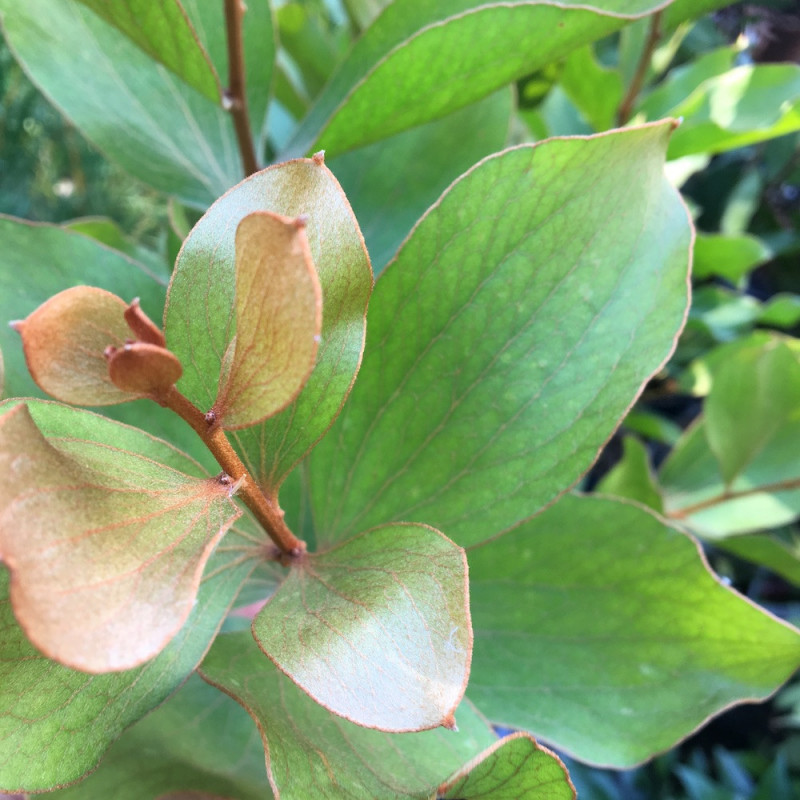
[73,0,222,103]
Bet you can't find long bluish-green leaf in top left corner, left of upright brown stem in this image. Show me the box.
[0,0,242,207]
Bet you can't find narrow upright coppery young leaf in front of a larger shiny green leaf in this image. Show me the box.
[213,211,322,429]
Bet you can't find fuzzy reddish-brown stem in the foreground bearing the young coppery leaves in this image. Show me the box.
[154,386,306,560]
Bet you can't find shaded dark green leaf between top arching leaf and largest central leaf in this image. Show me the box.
[329,88,513,275]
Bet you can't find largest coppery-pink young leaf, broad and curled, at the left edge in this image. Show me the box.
[0,405,240,672]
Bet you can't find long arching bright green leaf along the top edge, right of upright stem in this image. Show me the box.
[290,0,676,155]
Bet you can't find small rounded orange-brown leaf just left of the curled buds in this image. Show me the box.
[13,286,132,406]
